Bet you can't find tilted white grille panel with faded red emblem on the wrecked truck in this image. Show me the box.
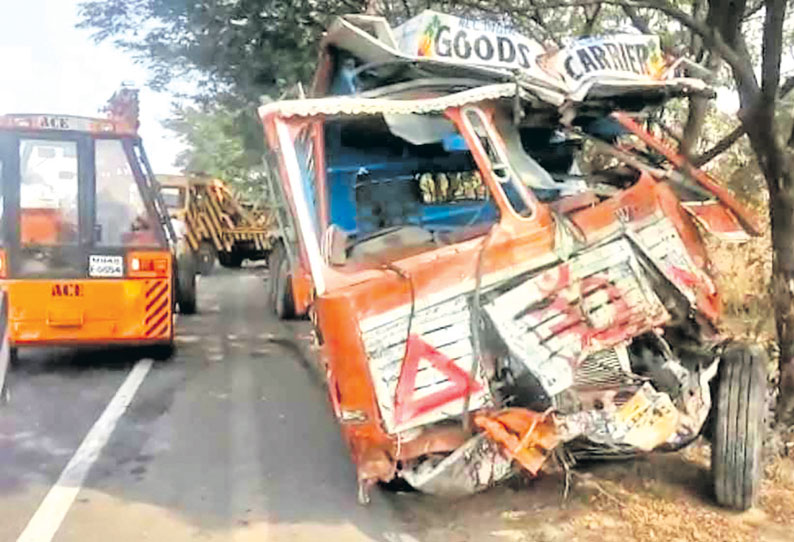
[485,239,667,396]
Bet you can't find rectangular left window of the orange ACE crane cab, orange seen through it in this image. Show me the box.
[19,139,79,246]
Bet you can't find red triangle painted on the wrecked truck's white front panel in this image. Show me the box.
[394,335,482,430]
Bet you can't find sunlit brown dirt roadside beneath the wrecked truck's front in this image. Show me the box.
[392,441,794,542]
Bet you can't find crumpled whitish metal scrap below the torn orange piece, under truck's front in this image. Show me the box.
[400,433,515,497]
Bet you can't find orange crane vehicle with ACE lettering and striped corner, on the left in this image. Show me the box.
[0,115,195,364]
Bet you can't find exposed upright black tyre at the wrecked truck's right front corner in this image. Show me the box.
[711,344,767,510]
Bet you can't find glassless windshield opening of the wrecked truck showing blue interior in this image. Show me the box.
[326,114,498,243]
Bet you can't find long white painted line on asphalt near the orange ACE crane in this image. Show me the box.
[17,359,152,542]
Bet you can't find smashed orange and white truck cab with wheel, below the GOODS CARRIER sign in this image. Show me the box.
[260,13,766,509]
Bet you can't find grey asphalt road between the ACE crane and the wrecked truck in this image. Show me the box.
[0,268,426,542]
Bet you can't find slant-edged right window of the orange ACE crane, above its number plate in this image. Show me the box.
[94,139,157,250]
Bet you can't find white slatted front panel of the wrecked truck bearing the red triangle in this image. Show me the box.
[362,295,492,433]
